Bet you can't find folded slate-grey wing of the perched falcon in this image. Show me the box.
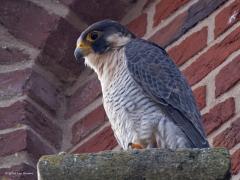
[125,39,209,148]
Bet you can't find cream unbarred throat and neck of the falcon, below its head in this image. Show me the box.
[85,48,124,88]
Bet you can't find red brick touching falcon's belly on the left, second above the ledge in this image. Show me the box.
[72,106,107,144]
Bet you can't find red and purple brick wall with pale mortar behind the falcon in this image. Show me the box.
[0,0,240,180]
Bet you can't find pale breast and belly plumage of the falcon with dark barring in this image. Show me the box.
[99,48,188,149]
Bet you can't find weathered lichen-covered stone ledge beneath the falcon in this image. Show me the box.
[38,148,231,180]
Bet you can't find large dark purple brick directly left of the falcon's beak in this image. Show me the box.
[37,18,85,84]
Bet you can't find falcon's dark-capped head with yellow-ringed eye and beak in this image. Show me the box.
[74,20,135,61]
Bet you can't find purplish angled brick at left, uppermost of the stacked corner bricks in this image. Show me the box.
[0,69,59,113]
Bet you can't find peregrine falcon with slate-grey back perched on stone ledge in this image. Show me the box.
[74,19,209,150]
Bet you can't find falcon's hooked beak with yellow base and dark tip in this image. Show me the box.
[74,42,92,62]
